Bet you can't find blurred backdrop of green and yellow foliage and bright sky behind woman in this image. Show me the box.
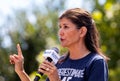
[0,0,120,81]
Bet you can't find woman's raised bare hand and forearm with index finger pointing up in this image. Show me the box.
[10,44,31,81]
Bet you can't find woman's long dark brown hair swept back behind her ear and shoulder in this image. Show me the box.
[59,8,108,59]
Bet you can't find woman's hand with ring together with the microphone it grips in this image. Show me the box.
[34,47,60,81]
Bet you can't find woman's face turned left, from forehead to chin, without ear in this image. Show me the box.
[58,18,80,48]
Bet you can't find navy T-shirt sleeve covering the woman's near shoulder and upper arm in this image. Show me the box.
[85,53,108,81]
